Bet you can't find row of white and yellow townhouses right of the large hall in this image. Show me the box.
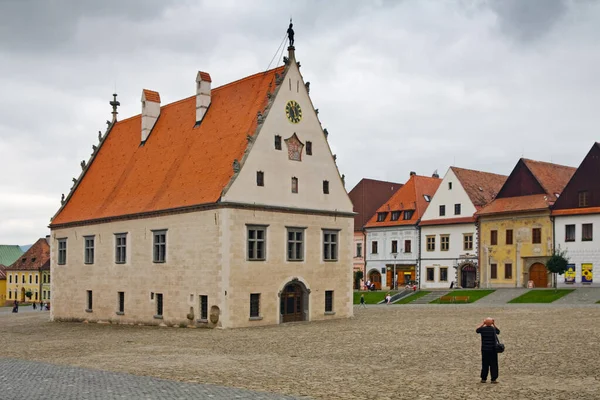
[357,143,600,288]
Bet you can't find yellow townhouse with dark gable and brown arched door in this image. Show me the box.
[476,158,575,287]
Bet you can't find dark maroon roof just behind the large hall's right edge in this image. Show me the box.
[348,178,402,231]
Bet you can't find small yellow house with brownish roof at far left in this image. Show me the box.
[5,238,50,303]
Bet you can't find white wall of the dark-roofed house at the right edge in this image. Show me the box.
[554,214,600,287]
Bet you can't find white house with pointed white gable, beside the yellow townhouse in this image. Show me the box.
[419,167,506,289]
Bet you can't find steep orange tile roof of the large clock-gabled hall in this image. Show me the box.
[51,66,284,227]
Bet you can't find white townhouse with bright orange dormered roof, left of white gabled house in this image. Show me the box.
[365,172,441,289]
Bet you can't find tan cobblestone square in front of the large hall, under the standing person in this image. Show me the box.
[0,303,600,400]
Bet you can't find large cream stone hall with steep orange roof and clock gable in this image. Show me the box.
[50,39,354,328]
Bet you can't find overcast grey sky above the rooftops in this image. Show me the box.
[0,0,600,244]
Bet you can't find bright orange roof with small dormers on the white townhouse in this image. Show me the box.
[365,175,442,228]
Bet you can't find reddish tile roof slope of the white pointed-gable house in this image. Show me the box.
[450,167,507,210]
